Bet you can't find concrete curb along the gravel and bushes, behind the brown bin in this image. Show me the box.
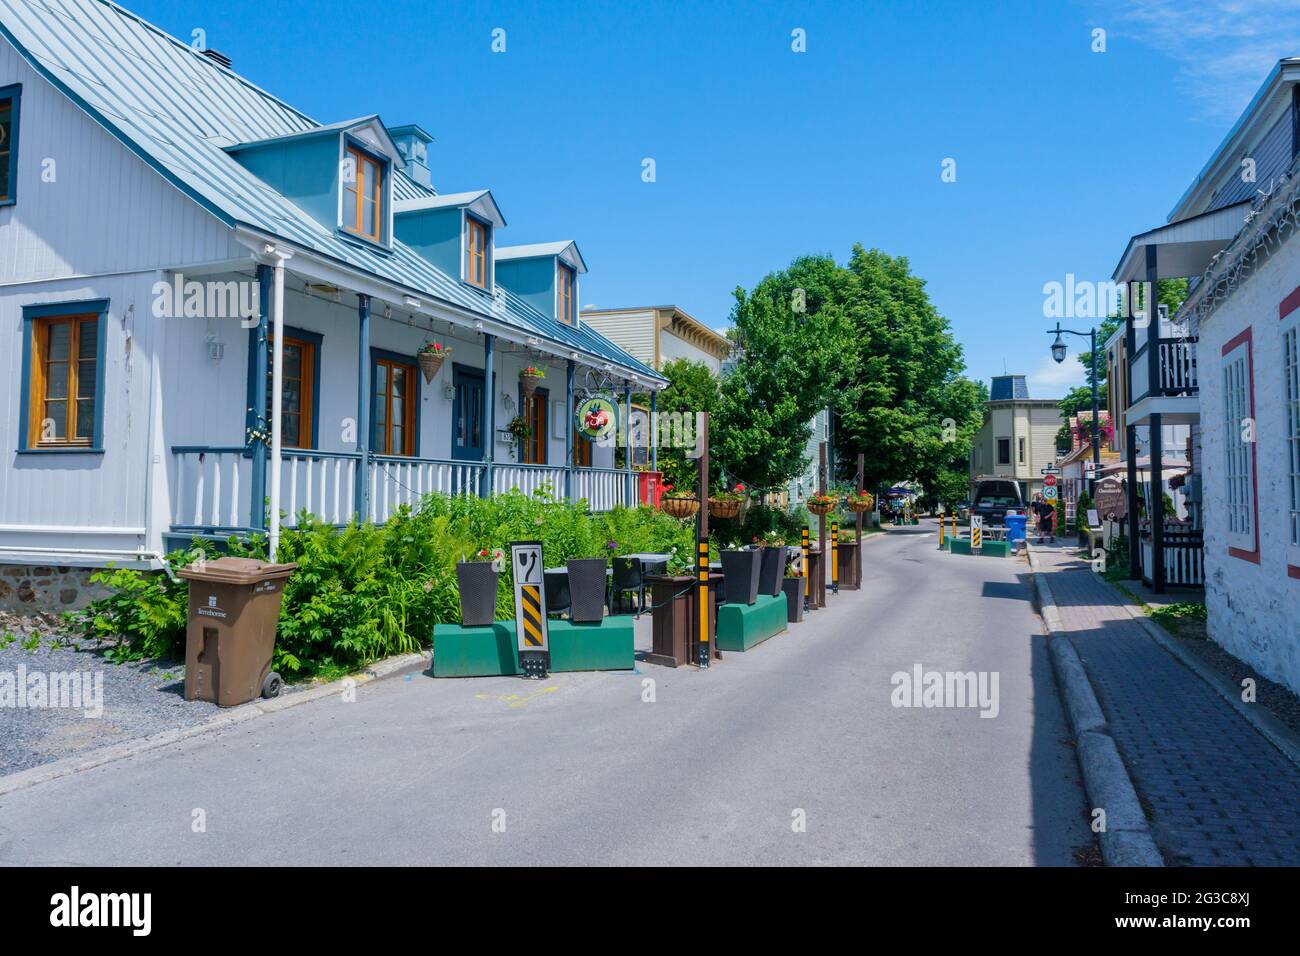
[0,653,429,796]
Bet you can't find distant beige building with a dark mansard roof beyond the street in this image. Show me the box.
[971,375,1063,501]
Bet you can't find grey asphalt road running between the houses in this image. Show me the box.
[0,525,1091,865]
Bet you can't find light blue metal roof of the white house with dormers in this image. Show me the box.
[0,0,664,381]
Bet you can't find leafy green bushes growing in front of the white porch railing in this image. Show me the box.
[65,492,694,679]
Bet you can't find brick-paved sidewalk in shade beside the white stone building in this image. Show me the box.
[1035,548,1300,866]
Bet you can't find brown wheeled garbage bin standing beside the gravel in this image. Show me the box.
[177,558,298,708]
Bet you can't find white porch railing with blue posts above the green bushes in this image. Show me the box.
[172,445,634,533]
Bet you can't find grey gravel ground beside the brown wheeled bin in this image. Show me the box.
[0,614,299,775]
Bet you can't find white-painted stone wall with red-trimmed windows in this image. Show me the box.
[1197,239,1300,692]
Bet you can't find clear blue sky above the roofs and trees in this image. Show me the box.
[126,0,1300,398]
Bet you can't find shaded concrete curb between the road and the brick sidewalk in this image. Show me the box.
[1024,541,1165,866]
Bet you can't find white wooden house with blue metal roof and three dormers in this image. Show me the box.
[0,0,666,590]
